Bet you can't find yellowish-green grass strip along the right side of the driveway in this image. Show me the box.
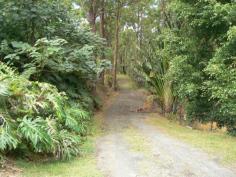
[146,114,236,165]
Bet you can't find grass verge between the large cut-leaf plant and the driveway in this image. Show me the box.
[16,115,103,177]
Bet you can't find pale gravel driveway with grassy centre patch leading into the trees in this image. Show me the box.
[97,76,236,177]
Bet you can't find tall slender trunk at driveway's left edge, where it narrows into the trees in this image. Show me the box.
[112,1,121,90]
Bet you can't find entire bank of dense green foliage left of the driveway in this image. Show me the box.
[0,0,110,162]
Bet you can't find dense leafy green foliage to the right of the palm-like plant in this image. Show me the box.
[166,1,236,133]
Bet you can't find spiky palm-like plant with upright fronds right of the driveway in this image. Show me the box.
[140,39,174,113]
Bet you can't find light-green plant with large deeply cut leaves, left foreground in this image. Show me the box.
[0,63,89,158]
